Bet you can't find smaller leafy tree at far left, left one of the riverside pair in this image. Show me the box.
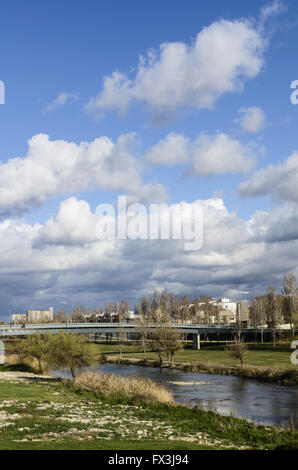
[14,333,50,374]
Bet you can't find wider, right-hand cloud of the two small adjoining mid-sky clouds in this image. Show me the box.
[191,134,255,177]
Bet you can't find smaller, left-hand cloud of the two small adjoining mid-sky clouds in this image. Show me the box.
[145,132,189,165]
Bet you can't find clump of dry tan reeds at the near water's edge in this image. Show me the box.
[73,371,173,403]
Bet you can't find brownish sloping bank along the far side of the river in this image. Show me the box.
[102,354,298,385]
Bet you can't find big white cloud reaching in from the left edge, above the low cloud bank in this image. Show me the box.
[0,134,166,210]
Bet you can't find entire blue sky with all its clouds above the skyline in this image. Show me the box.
[0,0,298,318]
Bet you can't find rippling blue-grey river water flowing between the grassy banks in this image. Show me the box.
[52,364,298,427]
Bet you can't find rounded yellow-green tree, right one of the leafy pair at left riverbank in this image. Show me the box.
[47,332,97,379]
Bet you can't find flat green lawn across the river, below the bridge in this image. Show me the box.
[94,343,297,369]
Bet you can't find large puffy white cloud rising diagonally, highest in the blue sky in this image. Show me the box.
[87,20,267,115]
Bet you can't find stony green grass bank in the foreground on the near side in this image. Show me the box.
[0,372,297,450]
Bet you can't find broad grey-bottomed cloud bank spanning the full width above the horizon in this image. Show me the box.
[0,198,298,309]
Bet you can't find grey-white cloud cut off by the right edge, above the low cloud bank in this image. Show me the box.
[237,152,298,202]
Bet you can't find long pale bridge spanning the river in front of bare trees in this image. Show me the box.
[0,323,285,349]
